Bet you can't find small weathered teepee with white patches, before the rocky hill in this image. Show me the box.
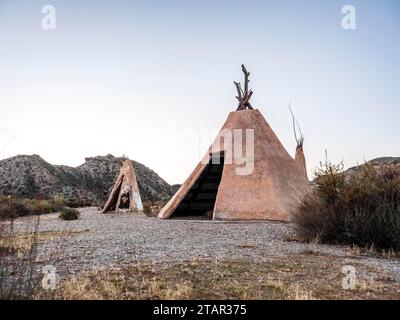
[102,160,143,213]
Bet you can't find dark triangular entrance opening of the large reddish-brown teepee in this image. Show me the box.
[172,153,224,219]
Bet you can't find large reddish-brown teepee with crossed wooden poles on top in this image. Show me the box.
[158,66,311,221]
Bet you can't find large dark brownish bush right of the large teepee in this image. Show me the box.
[294,162,400,251]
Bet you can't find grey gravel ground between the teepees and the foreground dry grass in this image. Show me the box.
[17,208,400,282]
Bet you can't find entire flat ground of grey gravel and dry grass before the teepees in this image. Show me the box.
[10,208,400,299]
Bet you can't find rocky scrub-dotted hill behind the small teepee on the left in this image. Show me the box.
[0,155,174,205]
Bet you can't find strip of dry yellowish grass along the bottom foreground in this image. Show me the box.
[41,255,400,300]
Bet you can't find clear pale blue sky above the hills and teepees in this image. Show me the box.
[0,0,400,183]
